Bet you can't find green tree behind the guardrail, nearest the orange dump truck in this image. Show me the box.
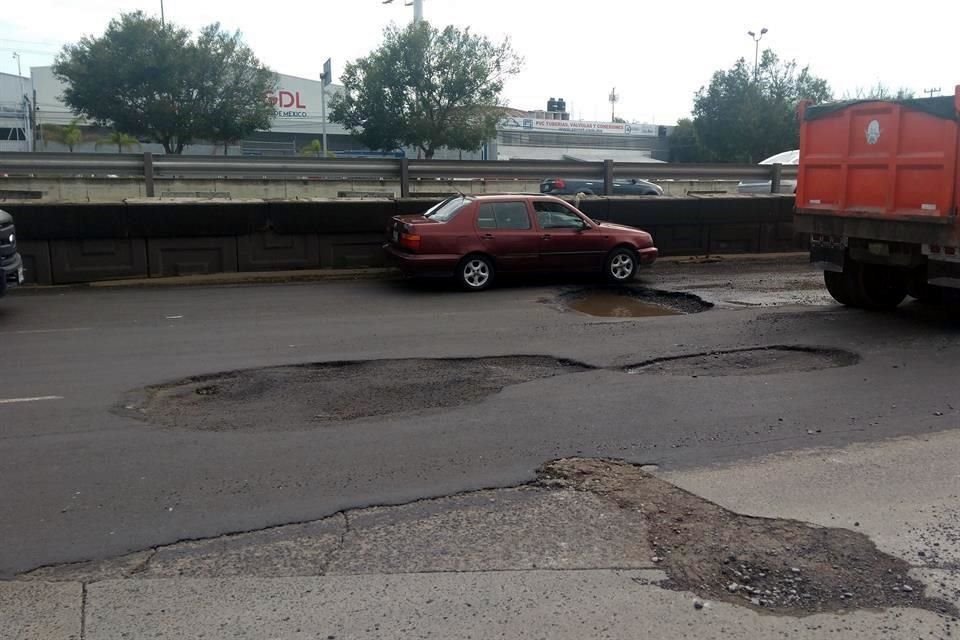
[693,49,832,163]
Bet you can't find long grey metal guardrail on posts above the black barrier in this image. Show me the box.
[0,152,797,197]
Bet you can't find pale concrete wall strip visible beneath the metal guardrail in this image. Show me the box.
[0,176,737,202]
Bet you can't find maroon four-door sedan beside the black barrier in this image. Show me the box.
[383,195,657,291]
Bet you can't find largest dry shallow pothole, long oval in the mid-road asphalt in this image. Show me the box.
[119,356,590,431]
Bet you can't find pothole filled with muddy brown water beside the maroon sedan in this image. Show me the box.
[560,287,713,318]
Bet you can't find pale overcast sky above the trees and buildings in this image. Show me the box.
[0,0,960,124]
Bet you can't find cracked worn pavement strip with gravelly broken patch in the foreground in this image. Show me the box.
[18,458,960,618]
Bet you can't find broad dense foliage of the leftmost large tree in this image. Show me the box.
[53,11,276,153]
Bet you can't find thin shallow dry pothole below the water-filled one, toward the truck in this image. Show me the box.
[626,345,860,376]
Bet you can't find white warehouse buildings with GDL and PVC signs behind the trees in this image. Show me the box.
[20,67,669,162]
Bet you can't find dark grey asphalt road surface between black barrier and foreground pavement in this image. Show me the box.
[0,258,960,594]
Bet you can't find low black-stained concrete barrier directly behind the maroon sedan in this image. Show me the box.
[3,196,802,284]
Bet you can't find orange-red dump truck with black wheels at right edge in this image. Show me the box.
[795,86,960,310]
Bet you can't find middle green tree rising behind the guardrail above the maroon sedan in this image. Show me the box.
[330,22,521,158]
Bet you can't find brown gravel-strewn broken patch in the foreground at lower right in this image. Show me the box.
[539,458,958,616]
